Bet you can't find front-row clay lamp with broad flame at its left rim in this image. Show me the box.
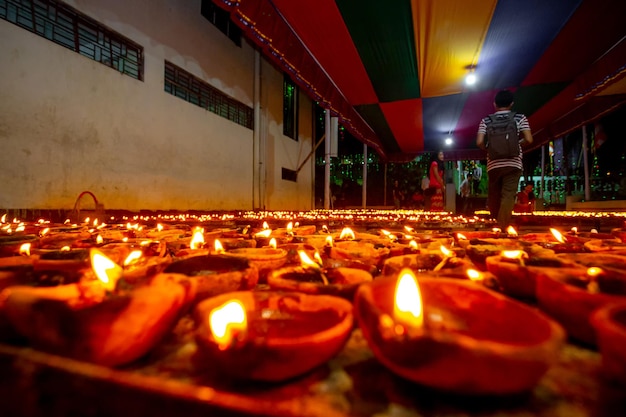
[194,291,353,382]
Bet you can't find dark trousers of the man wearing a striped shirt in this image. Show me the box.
[487,167,522,231]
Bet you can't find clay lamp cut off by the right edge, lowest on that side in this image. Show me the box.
[590,302,626,386]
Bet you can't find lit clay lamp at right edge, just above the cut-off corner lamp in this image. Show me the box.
[537,267,626,346]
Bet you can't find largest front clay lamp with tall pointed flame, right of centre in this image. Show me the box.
[354,269,564,395]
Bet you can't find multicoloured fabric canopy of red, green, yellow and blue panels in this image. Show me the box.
[213,0,626,162]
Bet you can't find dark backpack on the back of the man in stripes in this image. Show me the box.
[485,112,520,160]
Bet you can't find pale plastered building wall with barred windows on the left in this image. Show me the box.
[0,0,313,210]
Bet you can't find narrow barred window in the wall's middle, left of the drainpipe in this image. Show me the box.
[165,61,254,129]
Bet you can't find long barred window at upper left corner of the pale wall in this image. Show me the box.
[0,0,143,80]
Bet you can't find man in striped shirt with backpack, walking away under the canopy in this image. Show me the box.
[476,90,533,231]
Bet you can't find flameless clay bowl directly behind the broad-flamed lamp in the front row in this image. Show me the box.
[163,255,259,302]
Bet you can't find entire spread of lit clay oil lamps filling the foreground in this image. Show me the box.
[0,214,626,394]
